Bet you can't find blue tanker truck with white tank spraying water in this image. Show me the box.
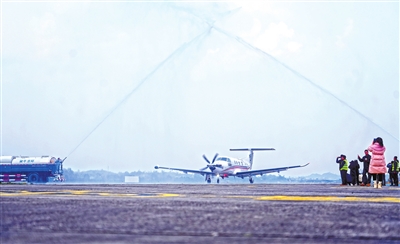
[0,156,65,183]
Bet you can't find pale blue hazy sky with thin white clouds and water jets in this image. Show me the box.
[1,1,400,176]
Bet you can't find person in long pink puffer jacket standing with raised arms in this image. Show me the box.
[368,137,386,188]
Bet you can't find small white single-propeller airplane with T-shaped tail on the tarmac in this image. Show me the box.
[154,148,310,184]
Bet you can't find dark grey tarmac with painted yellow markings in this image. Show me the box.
[0,184,400,244]
